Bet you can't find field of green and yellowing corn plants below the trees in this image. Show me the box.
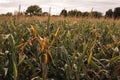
[0,17,120,80]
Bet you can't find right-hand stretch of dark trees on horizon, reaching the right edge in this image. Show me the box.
[60,7,120,19]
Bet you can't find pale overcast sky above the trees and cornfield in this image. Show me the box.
[0,0,120,14]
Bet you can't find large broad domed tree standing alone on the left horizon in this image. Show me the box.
[26,5,42,15]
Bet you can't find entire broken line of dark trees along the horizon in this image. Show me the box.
[1,5,120,19]
